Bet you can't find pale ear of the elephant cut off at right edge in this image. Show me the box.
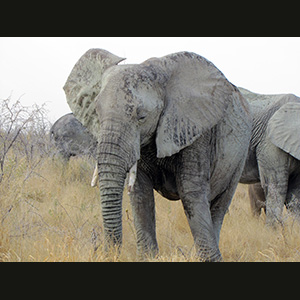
[267,102,300,160]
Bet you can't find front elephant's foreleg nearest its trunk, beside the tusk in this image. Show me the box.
[130,169,158,258]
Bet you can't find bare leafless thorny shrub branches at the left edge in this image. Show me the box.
[0,97,50,184]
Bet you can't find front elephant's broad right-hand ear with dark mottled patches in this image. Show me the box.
[153,52,241,157]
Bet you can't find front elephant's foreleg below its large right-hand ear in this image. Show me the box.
[177,141,222,261]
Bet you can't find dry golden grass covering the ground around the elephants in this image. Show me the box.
[0,158,300,262]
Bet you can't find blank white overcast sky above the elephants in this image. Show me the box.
[0,37,300,122]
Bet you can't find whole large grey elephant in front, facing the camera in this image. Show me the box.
[64,49,251,261]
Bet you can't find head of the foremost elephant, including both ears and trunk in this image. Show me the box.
[64,49,234,248]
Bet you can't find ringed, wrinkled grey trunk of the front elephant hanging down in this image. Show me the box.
[98,125,139,246]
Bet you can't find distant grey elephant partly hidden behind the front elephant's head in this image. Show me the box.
[50,113,97,161]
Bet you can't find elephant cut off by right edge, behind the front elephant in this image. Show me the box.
[239,88,300,227]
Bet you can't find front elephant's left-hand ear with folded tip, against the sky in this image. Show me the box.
[63,49,125,135]
